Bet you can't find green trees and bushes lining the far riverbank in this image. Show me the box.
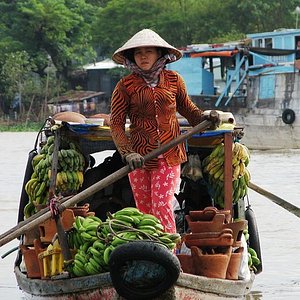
[0,0,299,127]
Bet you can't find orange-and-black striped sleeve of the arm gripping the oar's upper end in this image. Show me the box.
[177,74,203,126]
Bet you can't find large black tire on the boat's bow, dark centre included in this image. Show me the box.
[109,241,180,300]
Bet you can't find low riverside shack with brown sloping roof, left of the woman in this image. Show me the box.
[48,90,106,116]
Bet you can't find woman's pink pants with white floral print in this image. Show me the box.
[128,158,180,233]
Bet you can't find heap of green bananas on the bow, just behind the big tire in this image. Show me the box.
[68,207,181,276]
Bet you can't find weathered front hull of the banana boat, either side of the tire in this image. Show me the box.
[15,267,254,300]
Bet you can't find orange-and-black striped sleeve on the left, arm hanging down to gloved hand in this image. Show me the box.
[110,81,134,156]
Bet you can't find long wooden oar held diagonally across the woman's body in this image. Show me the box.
[0,120,212,247]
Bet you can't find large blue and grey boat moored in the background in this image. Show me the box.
[168,29,300,150]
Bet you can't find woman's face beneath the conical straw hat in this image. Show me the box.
[133,47,161,71]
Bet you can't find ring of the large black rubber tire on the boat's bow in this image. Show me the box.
[109,241,181,300]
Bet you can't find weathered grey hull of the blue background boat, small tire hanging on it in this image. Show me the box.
[232,72,300,150]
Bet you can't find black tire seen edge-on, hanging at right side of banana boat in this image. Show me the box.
[245,206,262,274]
